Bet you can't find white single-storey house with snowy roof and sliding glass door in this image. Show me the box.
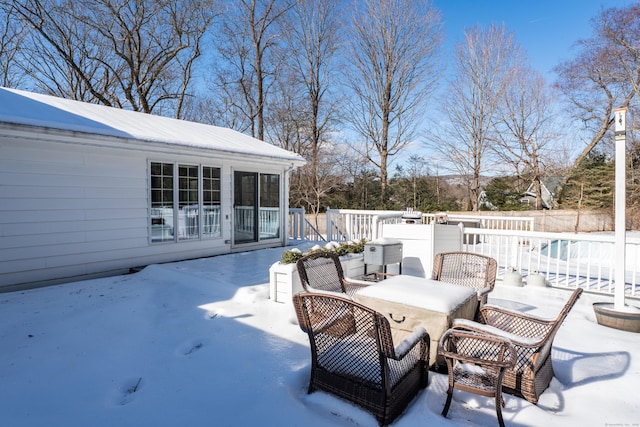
[0,88,304,291]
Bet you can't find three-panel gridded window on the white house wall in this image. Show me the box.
[150,162,221,242]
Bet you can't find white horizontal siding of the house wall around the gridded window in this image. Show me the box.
[0,136,230,288]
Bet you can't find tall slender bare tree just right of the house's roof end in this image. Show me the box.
[274,0,341,218]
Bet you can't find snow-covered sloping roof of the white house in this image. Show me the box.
[0,87,305,166]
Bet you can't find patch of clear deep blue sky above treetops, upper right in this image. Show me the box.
[433,0,637,79]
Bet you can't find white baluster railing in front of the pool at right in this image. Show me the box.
[463,228,640,297]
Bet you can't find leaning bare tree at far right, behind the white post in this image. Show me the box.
[556,2,640,204]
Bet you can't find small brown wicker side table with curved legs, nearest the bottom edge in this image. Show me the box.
[438,329,516,427]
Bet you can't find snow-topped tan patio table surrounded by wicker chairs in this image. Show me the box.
[353,274,478,367]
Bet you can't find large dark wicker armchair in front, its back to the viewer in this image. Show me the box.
[293,292,429,425]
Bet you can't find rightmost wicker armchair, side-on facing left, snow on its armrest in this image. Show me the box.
[453,288,582,404]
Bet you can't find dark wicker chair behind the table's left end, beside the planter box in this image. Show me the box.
[296,252,367,297]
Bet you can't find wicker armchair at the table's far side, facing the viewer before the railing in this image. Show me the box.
[431,252,498,307]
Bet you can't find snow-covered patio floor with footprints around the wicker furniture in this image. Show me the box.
[0,244,640,427]
